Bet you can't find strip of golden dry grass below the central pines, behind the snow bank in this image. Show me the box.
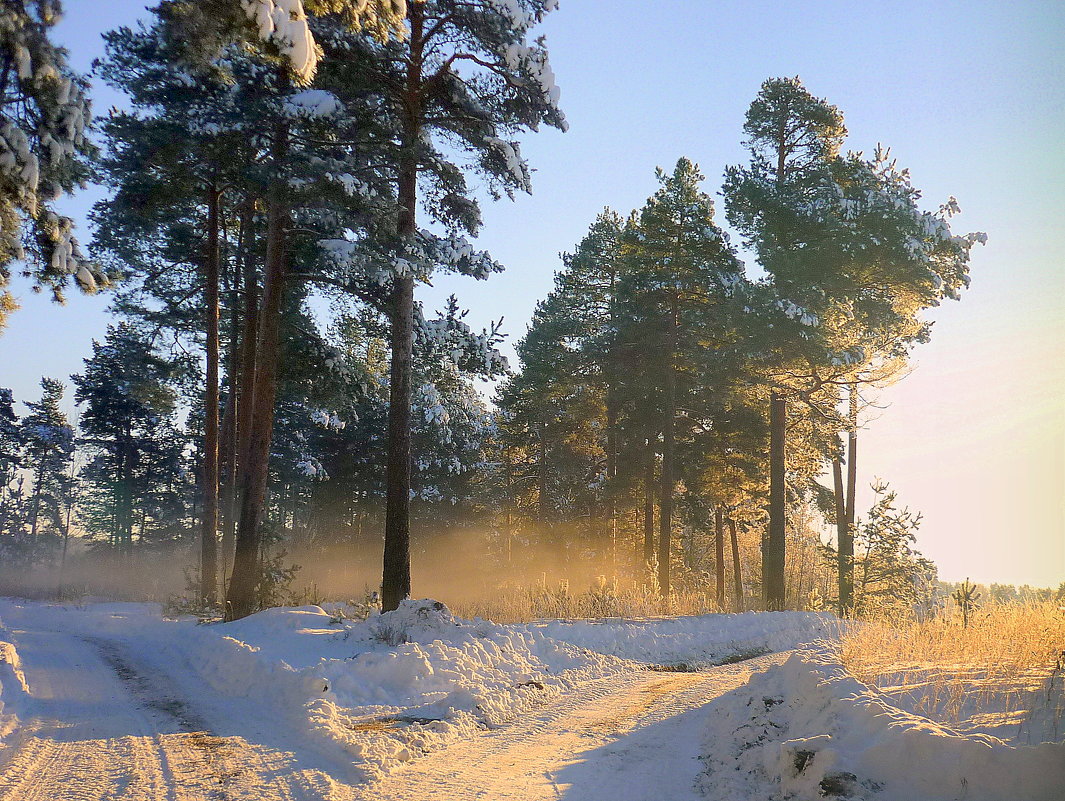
[449,576,719,623]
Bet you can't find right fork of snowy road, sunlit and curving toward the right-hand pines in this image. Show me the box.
[363,654,787,801]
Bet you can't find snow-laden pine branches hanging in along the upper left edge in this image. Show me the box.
[0,0,108,328]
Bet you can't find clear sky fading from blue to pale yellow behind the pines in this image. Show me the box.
[0,0,1065,586]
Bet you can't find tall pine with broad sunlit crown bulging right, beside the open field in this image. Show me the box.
[724,78,983,608]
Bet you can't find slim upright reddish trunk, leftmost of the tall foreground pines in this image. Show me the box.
[200,186,219,604]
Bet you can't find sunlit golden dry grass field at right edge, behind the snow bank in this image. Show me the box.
[841,603,1065,741]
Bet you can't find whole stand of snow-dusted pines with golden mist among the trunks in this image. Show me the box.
[0,0,986,619]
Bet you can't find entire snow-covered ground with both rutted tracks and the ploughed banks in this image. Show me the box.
[0,600,1065,801]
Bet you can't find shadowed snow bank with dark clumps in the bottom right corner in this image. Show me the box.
[701,643,1065,801]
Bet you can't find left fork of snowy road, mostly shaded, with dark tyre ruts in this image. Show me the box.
[0,605,359,801]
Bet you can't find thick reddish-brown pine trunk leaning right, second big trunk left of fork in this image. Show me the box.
[226,122,289,620]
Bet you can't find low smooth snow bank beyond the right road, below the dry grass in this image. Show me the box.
[525,611,838,668]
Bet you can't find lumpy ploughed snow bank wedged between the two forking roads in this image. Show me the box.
[185,601,630,775]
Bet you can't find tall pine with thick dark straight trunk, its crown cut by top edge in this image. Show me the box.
[313,0,566,609]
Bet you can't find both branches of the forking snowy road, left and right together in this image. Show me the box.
[0,605,785,801]
